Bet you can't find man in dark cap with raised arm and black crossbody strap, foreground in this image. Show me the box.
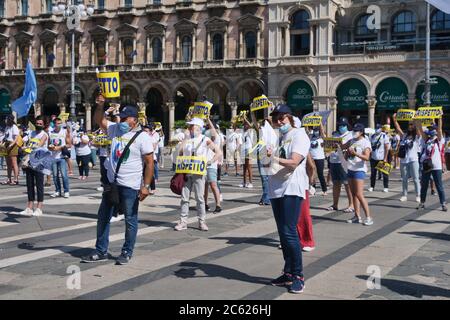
[82,95,153,265]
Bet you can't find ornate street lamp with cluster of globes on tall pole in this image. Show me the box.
[52,0,94,122]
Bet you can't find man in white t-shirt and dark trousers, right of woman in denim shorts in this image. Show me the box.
[369,124,391,192]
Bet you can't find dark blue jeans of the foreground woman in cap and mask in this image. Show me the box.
[270,196,303,277]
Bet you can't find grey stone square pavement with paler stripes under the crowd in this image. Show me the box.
[0,162,450,300]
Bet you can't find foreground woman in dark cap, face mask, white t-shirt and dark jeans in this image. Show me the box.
[267,105,310,293]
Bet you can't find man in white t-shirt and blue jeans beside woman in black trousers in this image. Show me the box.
[48,118,70,199]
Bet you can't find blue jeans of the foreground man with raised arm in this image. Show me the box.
[95,186,139,257]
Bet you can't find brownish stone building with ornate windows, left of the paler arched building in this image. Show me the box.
[0,0,268,139]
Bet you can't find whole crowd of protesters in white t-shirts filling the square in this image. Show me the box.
[0,95,450,293]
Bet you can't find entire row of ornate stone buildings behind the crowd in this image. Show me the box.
[0,0,450,134]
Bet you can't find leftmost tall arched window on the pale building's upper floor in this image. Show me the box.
[290,10,310,56]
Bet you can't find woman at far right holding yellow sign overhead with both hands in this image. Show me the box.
[416,119,447,212]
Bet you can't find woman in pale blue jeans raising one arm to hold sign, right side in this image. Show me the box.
[392,113,420,202]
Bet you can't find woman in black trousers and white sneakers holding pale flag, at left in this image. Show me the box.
[19,116,48,217]
